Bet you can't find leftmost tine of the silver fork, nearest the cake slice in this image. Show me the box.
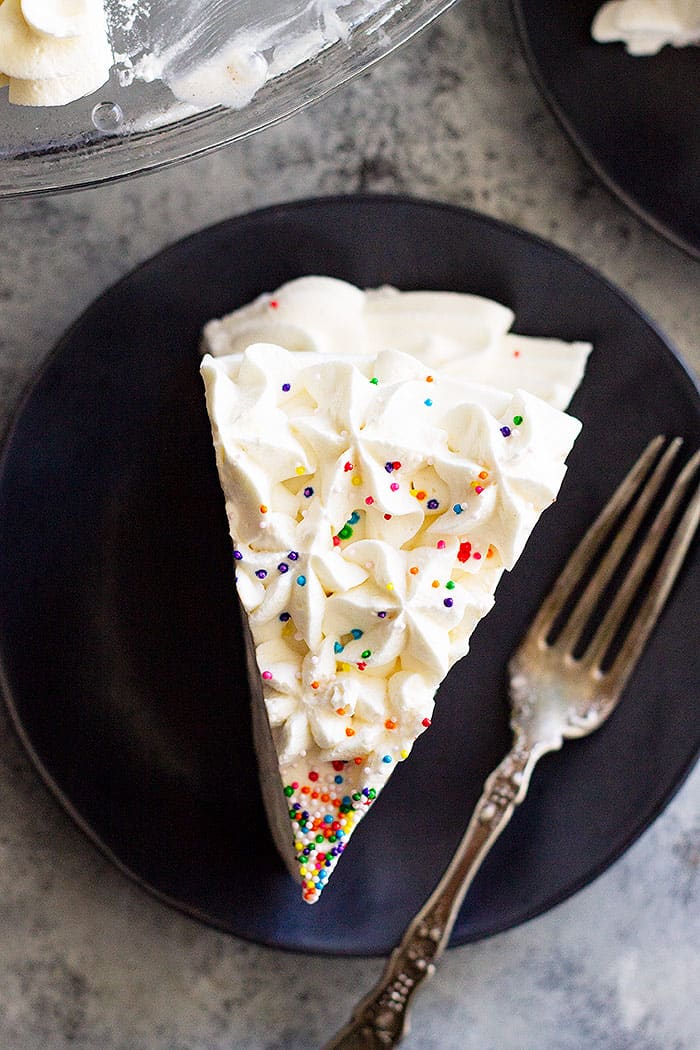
[525,435,665,645]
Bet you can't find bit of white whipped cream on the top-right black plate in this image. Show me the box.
[591,0,700,55]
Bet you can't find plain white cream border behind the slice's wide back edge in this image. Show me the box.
[204,276,591,408]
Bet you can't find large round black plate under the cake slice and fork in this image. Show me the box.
[0,197,700,953]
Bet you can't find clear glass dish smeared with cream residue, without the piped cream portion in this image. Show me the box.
[0,0,453,197]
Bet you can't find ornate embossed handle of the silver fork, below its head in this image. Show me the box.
[324,740,549,1050]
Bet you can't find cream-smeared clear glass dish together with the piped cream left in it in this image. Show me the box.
[0,0,454,197]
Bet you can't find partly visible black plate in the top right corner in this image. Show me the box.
[512,0,700,257]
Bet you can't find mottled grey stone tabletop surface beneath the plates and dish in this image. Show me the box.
[0,0,700,1050]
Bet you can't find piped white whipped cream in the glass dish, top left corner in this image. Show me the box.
[0,0,112,106]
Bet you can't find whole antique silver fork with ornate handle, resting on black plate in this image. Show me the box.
[324,436,700,1050]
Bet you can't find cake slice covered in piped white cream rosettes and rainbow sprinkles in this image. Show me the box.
[201,343,580,902]
